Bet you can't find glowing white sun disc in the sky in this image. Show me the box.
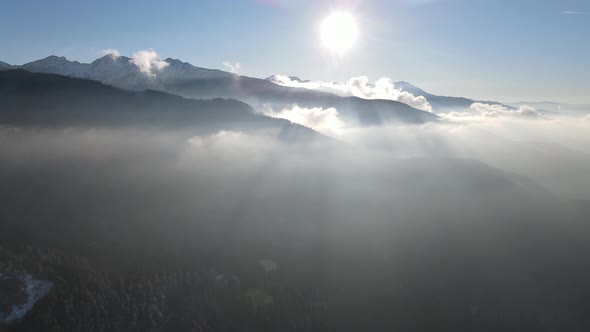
[320,13,359,55]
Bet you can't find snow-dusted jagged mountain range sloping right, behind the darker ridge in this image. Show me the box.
[12,55,438,125]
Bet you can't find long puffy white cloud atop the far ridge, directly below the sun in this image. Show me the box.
[270,75,432,112]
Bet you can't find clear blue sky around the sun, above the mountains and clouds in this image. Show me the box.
[0,0,590,103]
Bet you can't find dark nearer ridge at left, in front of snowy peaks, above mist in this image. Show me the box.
[0,69,318,137]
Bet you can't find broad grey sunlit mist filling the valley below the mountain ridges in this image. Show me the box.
[0,107,590,330]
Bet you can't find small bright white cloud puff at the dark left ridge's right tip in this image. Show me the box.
[264,104,344,136]
